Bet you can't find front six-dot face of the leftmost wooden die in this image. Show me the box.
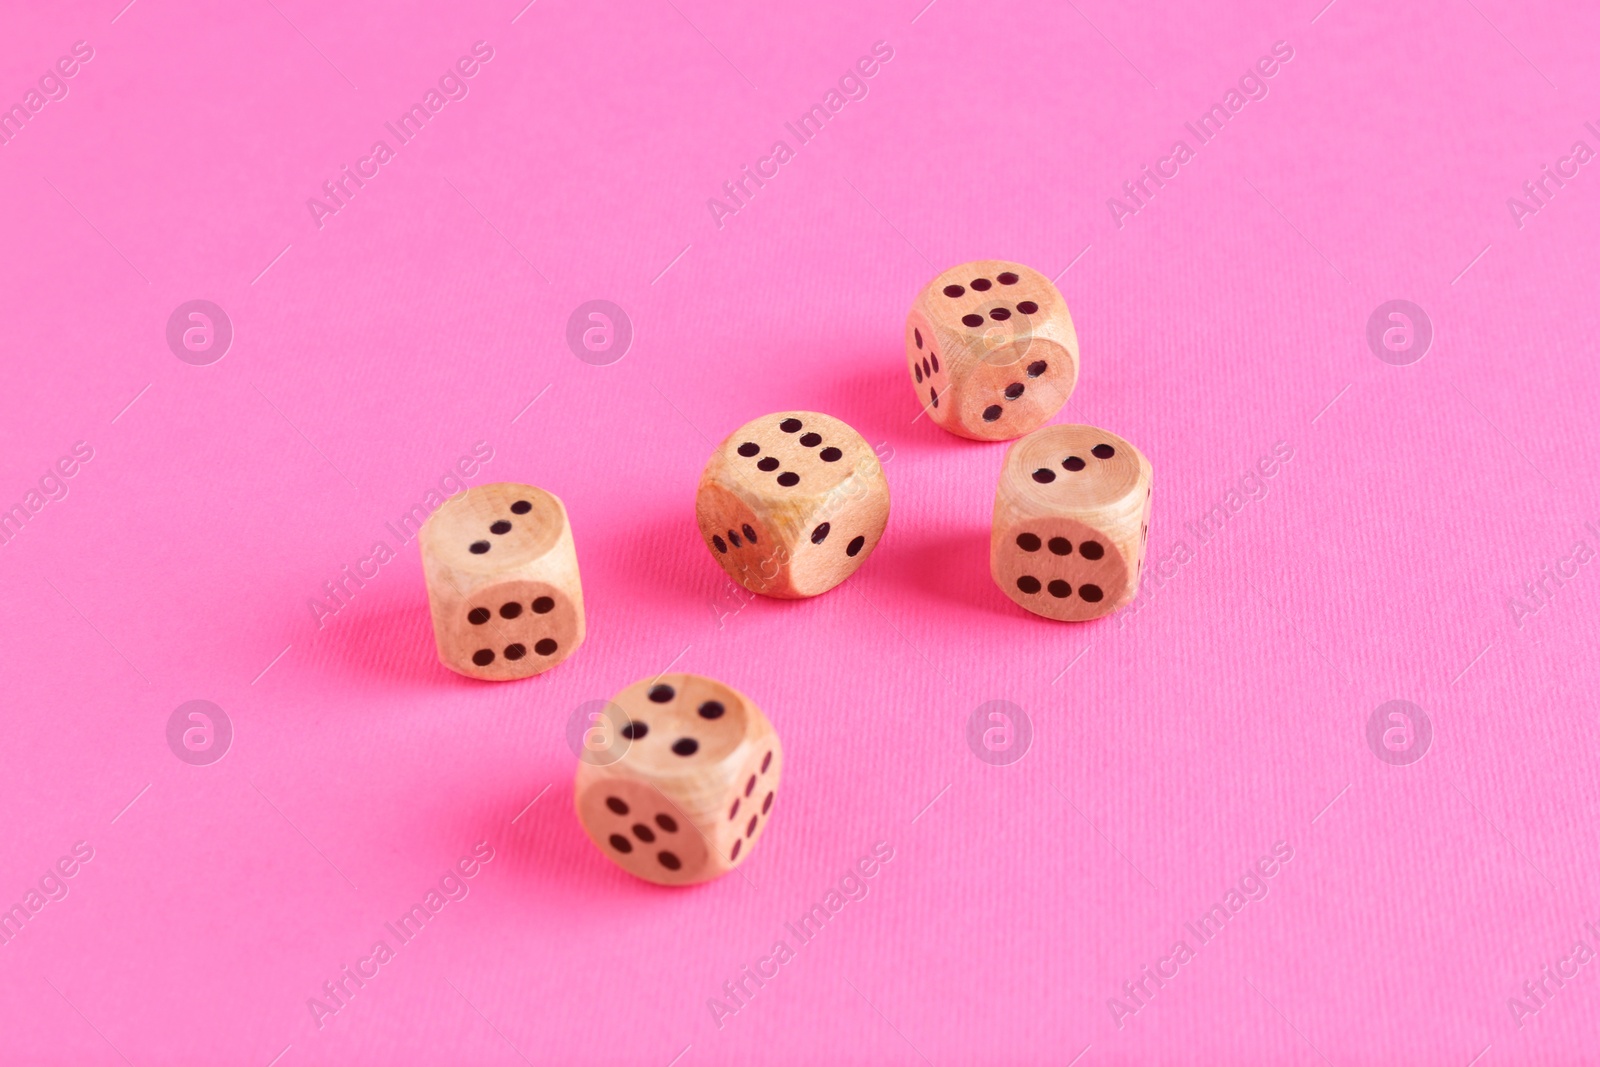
[434,581,582,681]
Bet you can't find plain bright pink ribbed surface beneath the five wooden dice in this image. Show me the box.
[0,0,1600,1067]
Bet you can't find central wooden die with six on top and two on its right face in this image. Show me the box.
[694,411,890,600]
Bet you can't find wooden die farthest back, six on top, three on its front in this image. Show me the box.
[906,259,1078,442]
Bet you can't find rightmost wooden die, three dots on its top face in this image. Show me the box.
[989,426,1150,621]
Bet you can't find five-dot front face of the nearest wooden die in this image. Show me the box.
[578,777,710,886]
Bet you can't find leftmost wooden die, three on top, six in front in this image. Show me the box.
[419,482,584,681]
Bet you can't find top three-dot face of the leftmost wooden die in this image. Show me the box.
[422,482,566,574]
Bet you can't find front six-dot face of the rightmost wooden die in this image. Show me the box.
[989,518,1131,622]
